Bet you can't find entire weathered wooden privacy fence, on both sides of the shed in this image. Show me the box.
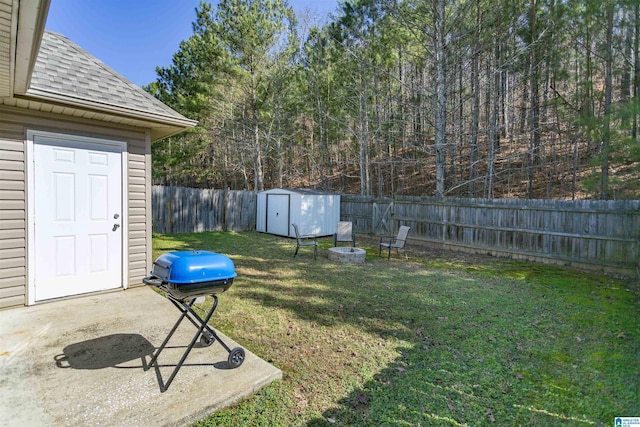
[152,186,640,275]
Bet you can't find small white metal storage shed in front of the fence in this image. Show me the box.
[256,188,340,237]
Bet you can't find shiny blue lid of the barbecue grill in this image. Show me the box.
[153,251,236,284]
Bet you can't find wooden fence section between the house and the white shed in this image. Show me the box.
[151,185,256,234]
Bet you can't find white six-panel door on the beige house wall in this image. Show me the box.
[31,135,123,301]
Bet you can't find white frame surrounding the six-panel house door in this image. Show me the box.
[25,129,129,305]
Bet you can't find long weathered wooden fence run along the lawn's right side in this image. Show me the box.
[394,197,640,274]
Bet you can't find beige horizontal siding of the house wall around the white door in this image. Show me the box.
[0,107,151,309]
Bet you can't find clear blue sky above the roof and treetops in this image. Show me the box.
[46,0,339,86]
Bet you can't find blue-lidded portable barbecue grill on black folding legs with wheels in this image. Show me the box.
[143,251,245,392]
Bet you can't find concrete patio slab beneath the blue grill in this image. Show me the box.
[0,287,282,426]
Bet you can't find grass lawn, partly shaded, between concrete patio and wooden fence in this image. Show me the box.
[153,232,640,427]
